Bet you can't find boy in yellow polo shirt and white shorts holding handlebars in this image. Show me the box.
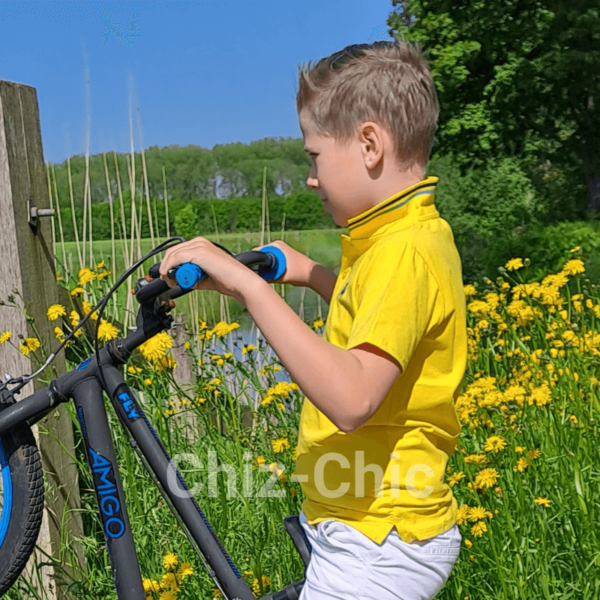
[161,42,467,600]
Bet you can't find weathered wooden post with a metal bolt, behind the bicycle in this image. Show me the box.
[0,81,84,599]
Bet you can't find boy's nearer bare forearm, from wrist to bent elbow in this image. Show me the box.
[241,276,368,433]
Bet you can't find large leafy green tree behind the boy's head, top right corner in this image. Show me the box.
[388,0,600,210]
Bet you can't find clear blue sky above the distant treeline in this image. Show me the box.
[0,0,393,162]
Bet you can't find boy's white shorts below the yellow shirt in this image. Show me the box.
[299,511,462,600]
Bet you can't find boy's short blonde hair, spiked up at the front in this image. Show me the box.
[296,41,440,171]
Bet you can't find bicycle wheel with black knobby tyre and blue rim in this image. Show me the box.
[0,426,44,596]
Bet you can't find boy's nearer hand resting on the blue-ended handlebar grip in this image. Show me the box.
[160,237,258,304]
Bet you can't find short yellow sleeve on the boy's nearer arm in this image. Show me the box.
[346,243,443,374]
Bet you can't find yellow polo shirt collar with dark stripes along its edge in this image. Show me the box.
[348,177,439,239]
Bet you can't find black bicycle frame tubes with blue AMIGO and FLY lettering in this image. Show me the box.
[0,321,304,600]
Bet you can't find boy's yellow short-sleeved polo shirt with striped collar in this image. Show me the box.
[295,177,467,543]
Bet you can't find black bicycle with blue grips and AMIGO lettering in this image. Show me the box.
[0,237,311,600]
